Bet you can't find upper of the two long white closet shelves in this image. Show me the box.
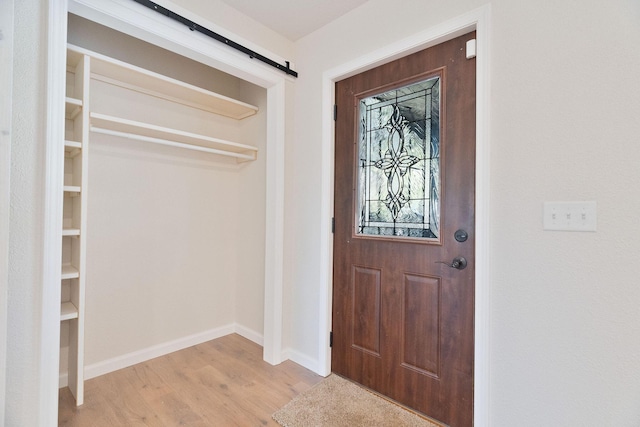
[68,45,258,120]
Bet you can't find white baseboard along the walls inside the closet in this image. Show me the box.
[59,323,264,387]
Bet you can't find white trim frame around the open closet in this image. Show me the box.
[38,0,292,425]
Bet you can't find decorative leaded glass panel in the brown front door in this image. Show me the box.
[356,77,440,239]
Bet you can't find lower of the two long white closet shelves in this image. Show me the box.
[90,113,258,161]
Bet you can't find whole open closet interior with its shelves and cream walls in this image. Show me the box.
[60,14,266,405]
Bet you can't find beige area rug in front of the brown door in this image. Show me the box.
[273,374,440,427]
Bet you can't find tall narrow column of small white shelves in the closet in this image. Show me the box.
[60,50,91,406]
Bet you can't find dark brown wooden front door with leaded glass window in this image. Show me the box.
[332,33,475,426]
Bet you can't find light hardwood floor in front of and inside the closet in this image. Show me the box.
[58,334,322,427]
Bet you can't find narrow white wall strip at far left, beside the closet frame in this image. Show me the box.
[3,0,47,426]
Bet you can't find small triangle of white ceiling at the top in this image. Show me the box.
[216,0,367,41]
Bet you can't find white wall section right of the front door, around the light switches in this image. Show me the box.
[491,0,640,426]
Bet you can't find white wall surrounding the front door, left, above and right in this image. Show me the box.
[287,0,640,426]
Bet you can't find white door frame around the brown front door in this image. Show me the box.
[318,5,491,427]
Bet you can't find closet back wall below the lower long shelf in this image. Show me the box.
[85,120,238,365]
